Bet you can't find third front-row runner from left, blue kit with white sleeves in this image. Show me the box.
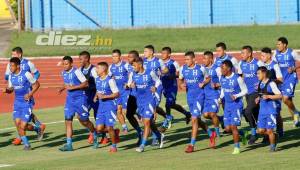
[93,62,120,152]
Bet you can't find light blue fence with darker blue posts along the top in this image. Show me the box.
[24,0,300,30]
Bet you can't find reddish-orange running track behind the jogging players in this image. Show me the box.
[0,53,300,113]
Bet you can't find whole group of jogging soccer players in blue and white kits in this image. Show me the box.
[3,37,300,154]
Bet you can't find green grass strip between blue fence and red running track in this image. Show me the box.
[6,25,300,57]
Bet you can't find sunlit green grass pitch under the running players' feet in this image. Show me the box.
[0,88,300,170]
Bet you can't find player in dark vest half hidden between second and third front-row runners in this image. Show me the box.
[79,51,99,144]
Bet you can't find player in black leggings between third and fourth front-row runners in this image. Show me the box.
[126,50,143,146]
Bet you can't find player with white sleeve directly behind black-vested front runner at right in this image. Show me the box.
[261,47,284,137]
